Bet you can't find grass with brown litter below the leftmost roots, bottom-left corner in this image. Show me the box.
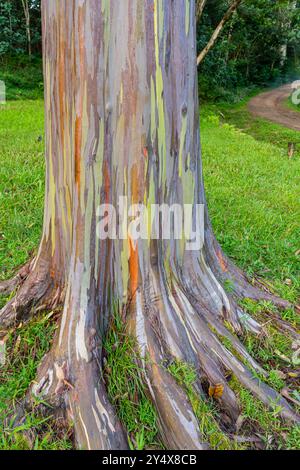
[0,313,73,450]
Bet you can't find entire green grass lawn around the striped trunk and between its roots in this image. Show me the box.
[0,96,300,449]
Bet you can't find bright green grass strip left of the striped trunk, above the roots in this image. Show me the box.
[0,101,44,279]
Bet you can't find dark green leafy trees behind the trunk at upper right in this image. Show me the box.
[197,0,300,100]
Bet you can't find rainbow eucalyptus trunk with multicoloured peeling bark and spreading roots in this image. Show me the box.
[0,0,297,449]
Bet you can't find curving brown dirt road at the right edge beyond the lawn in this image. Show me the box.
[248,85,300,131]
